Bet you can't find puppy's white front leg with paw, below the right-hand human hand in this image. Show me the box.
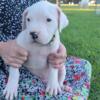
[46,64,61,96]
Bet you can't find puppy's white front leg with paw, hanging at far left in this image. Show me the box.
[3,67,19,100]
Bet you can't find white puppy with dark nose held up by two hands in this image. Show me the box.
[4,1,68,100]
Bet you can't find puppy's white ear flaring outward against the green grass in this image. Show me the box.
[57,6,69,32]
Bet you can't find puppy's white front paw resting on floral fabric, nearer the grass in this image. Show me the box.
[46,82,61,96]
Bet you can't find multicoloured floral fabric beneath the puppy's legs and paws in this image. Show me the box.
[0,57,91,100]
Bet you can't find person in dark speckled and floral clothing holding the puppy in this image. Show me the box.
[0,0,90,100]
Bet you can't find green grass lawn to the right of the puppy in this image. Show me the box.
[61,6,100,100]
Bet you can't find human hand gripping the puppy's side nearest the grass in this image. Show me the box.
[48,44,67,69]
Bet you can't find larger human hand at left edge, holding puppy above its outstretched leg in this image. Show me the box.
[0,40,28,67]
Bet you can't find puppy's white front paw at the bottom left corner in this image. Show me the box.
[3,80,18,100]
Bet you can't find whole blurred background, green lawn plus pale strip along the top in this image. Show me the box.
[48,0,100,100]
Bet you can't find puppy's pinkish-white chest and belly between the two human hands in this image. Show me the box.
[25,53,49,80]
